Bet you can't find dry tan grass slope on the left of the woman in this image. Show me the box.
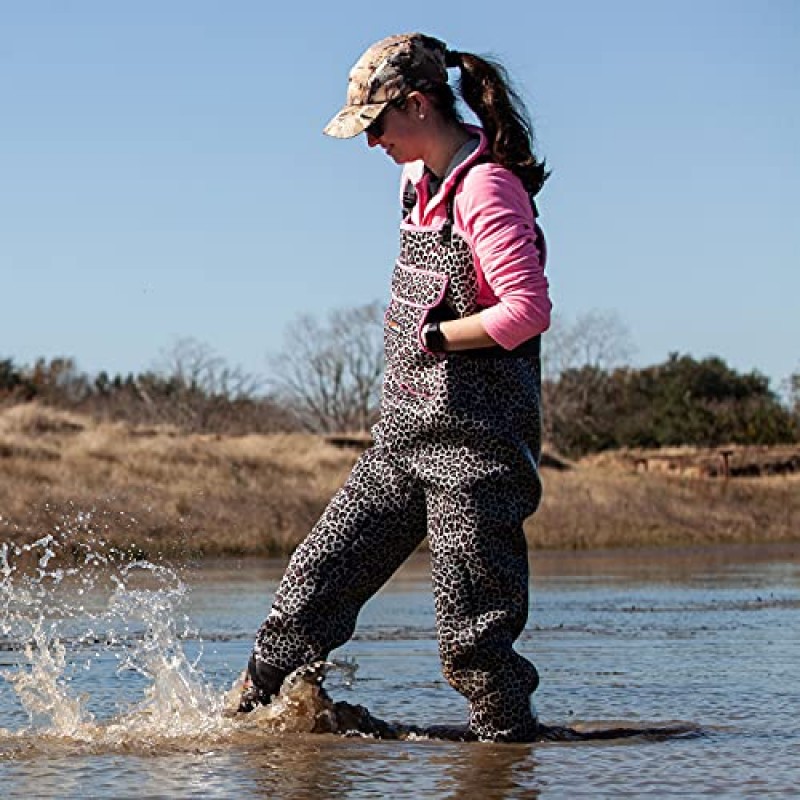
[0,406,355,555]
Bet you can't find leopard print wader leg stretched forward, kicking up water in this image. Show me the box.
[254,447,426,694]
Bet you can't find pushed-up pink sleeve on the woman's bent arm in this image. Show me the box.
[455,164,552,350]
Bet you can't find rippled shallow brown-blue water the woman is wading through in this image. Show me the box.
[0,540,800,800]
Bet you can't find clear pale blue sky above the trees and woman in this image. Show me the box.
[0,0,800,386]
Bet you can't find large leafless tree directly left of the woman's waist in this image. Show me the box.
[271,302,383,433]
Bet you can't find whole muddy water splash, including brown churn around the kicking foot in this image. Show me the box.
[0,513,366,756]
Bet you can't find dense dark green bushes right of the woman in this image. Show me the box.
[543,353,800,456]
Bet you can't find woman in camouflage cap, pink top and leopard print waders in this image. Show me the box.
[241,33,550,741]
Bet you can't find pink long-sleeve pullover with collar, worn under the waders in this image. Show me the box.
[401,126,552,350]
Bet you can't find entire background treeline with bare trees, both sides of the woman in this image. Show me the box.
[0,303,800,457]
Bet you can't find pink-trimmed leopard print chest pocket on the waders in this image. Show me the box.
[384,262,449,397]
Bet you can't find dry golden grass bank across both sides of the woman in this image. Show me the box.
[0,404,800,558]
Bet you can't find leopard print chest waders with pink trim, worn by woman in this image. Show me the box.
[255,178,541,741]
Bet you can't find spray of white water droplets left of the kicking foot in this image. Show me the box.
[0,514,228,747]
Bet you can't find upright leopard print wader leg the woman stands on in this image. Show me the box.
[427,477,539,741]
